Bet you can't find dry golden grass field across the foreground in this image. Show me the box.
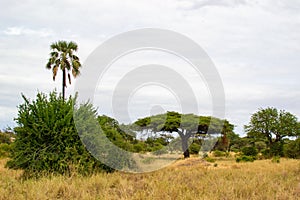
[0,158,300,200]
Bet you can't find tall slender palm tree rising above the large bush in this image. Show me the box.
[46,41,81,99]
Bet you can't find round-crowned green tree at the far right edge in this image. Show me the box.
[245,108,300,155]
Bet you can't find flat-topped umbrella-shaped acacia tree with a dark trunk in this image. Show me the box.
[134,112,233,158]
